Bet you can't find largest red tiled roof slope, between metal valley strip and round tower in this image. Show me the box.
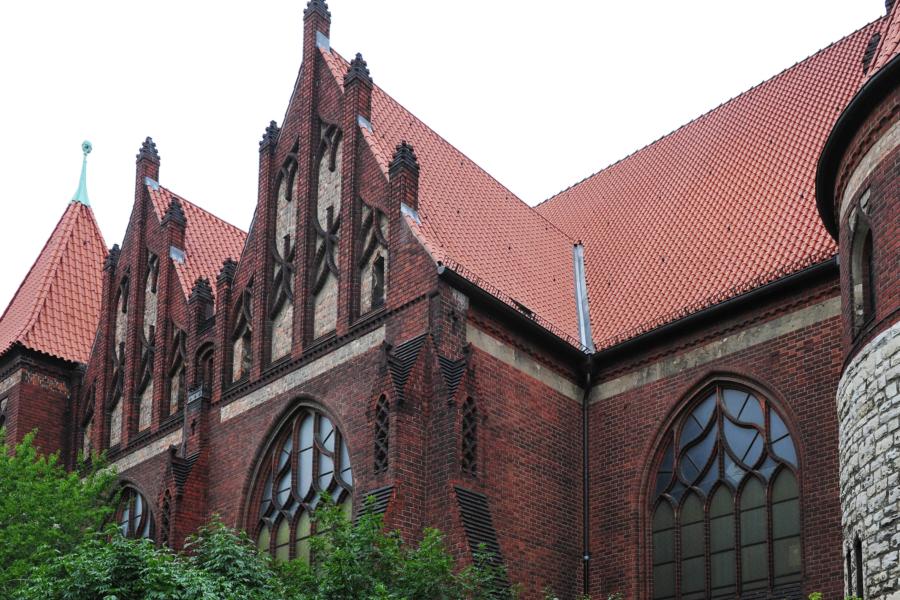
[538,20,882,348]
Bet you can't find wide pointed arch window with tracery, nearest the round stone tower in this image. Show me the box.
[650,383,802,600]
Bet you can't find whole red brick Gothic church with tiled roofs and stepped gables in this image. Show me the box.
[0,0,900,599]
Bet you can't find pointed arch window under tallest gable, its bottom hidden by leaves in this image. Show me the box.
[251,406,353,561]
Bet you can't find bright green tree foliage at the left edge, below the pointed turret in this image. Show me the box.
[0,429,115,595]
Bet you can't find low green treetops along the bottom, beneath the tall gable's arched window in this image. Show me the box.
[8,494,505,600]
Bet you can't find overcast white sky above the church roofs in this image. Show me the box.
[0,0,884,307]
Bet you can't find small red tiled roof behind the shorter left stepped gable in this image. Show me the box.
[147,184,247,297]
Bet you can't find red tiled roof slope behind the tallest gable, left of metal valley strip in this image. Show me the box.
[321,49,578,345]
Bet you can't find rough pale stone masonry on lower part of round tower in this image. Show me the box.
[837,322,900,600]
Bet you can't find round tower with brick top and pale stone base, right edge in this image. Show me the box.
[816,12,900,600]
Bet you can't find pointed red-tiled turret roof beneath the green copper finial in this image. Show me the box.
[0,202,106,363]
